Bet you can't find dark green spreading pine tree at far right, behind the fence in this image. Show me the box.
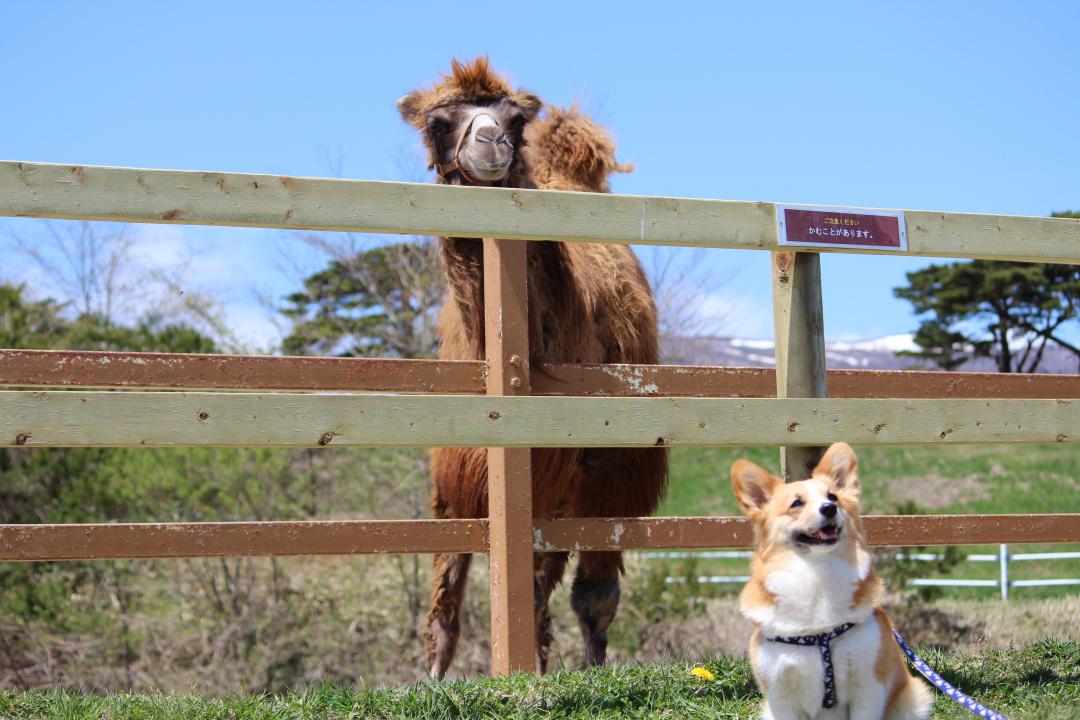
[894,212,1080,372]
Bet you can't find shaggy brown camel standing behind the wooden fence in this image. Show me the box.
[397,58,667,677]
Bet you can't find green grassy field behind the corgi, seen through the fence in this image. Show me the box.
[660,445,1080,599]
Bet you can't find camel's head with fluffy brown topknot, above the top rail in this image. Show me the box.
[397,57,542,187]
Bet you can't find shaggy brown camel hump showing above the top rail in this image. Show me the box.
[525,105,634,192]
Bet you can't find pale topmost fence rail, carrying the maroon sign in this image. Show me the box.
[0,161,1080,263]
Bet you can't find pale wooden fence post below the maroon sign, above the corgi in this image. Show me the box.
[772,250,827,483]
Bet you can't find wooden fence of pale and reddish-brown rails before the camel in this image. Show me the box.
[0,162,1080,673]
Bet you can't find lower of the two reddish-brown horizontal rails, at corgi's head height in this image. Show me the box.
[0,514,1080,562]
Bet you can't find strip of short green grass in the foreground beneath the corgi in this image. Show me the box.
[0,641,1080,720]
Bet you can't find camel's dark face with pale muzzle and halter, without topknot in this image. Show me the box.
[422,98,526,185]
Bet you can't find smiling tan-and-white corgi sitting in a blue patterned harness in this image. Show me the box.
[731,443,933,720]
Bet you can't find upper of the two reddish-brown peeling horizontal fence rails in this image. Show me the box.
[8,350,1080,398]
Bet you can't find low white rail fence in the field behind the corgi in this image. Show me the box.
[638,545,1080,600]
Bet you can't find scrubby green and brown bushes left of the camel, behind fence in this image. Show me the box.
[0,283,427,691]
